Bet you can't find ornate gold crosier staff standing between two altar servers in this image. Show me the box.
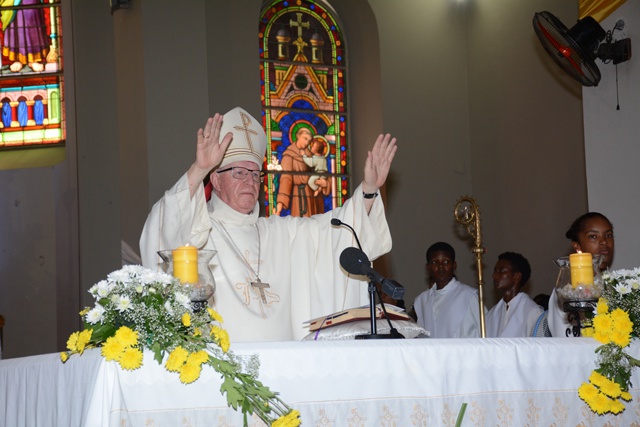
[453,196,487,338]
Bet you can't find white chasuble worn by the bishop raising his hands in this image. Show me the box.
[140,174,391,341]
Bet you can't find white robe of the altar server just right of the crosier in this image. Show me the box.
[486,292,543,338]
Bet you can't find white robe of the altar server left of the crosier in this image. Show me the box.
[414,278,480,338]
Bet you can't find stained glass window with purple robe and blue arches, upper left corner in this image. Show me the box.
[0,0,65,151]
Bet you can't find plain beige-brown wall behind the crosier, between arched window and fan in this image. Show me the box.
[370,0,586,307]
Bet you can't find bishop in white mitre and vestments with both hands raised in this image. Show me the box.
[140,107,397,341]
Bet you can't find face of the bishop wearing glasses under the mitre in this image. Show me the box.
[211,161,261,214]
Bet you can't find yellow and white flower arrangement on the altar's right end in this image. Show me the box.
[578,268,640,415]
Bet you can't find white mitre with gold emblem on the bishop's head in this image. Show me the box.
[218,107,267,169]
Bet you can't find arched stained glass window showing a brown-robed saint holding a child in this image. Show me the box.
[259,0,349,216]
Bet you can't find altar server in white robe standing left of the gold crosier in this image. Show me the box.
[414,242,480,338]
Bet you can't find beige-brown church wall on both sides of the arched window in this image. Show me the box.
[0,0,608,357]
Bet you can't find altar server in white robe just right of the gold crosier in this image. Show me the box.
[486,252,544,338]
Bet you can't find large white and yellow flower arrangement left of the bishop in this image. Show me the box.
[60,266,300,427]
